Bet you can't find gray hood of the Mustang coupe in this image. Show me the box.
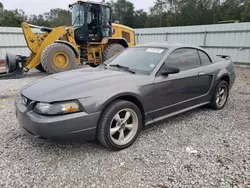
[21,68,149,102]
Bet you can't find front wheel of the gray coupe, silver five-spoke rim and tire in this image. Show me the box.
[97,100,142,150]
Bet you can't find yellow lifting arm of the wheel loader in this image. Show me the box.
[23,23,73,72]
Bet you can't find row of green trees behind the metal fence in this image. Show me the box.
[0,0,250,28]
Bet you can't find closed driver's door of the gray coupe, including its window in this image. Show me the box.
[154,48,210,119]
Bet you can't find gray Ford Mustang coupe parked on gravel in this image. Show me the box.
[15,43,235,150]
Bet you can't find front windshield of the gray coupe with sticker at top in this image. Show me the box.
[105,47,167,74]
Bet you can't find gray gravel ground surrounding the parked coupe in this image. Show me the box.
[0,68,250,188]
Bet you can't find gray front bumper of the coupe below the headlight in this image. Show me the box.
[15,99,101,141]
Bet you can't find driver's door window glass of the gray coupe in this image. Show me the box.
[165,48,201,71]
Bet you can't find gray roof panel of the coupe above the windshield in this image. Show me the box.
[136,42,204,50]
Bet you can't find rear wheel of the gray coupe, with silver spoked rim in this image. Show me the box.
[210,80,229,110]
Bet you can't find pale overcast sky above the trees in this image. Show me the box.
[0,0,153,14]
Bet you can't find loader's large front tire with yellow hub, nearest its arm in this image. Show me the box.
[41,43,76,74]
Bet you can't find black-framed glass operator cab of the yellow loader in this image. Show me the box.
[70,1,112,45]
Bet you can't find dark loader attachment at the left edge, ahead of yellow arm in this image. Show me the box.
[0,53,26,79]
